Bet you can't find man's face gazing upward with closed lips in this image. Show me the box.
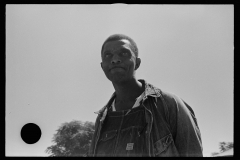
[101,39,140,82]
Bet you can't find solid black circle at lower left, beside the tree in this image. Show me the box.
[21,123,42,144]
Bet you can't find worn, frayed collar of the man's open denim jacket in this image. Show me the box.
[94,79,160,114]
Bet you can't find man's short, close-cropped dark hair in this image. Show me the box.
[101,34,138,58]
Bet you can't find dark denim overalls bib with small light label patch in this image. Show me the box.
[96,106,146,157]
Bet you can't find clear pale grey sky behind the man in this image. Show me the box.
[5,4,234,156]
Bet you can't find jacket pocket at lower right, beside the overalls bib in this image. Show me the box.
[154,134,177,156]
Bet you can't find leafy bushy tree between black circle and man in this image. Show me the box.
[45,120,94,157]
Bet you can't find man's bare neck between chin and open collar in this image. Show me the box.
[113,78,145,102]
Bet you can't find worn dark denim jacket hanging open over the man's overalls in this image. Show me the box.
[87,79,203,157]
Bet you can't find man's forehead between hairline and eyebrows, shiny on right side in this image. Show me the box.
[103,39,132,52]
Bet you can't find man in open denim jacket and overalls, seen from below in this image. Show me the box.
[88,34,203,157]
